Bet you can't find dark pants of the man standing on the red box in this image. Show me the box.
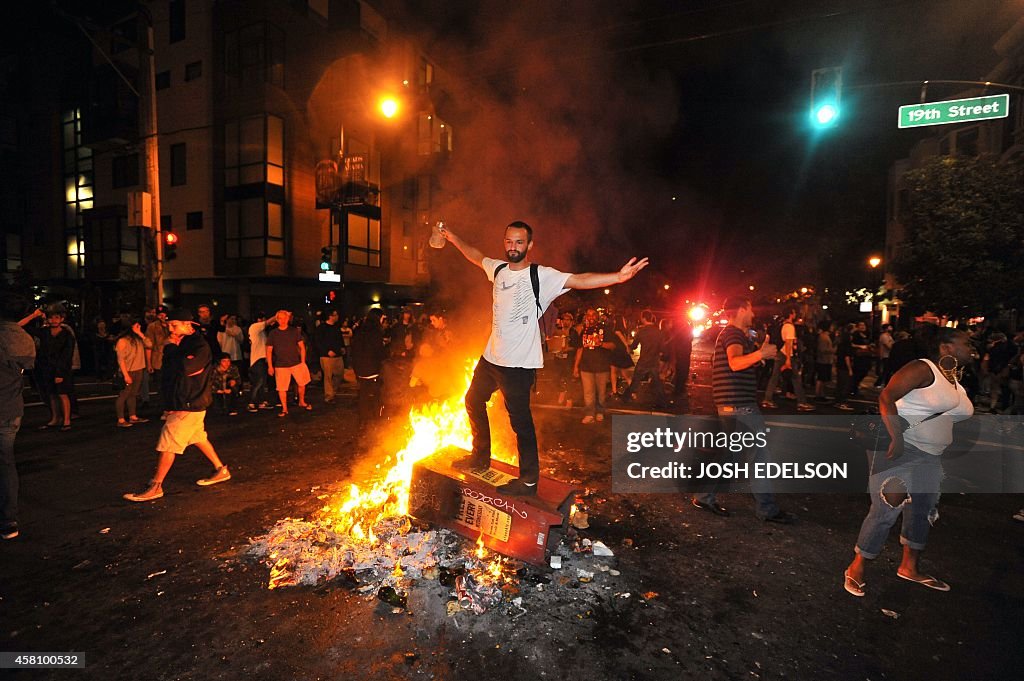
[466,357,540,482]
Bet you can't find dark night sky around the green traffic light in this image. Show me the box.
[385,0,1022,295]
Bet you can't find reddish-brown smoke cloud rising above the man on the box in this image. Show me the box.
[391,1,689,315]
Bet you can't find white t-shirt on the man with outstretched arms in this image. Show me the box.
[482,258,571,369]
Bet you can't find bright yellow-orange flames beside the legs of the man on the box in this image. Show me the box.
[323,360,507,546]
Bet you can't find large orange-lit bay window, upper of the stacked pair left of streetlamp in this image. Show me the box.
[224,116,285,186]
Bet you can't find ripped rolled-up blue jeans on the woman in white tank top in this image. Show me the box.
[854,443,942,559]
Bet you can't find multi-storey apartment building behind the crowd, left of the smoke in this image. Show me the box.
[0,0,453,315]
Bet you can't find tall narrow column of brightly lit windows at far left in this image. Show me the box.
[61,109,92,279]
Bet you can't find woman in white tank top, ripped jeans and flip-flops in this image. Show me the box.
[843,325,974,596]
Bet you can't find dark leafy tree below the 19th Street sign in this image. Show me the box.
[892,157,1024,317]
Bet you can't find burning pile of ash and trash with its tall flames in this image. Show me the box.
[249,363,522,612]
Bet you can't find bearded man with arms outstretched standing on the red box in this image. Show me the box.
[440,220,647,496]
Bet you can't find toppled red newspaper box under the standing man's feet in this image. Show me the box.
[409,446,574,565]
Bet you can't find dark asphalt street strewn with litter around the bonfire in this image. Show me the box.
[0,358,1024,680]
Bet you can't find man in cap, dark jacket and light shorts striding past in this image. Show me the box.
[124,309,231,502]
